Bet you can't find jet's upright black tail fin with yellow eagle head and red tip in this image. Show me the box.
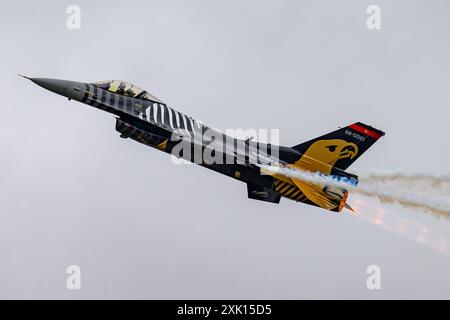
[292,122,384,170]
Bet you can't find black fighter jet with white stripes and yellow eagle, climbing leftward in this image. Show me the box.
[23,76,384,212]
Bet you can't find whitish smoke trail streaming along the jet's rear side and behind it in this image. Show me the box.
[263,166,450,220]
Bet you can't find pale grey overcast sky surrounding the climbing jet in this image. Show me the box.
[0,0,450,299]
